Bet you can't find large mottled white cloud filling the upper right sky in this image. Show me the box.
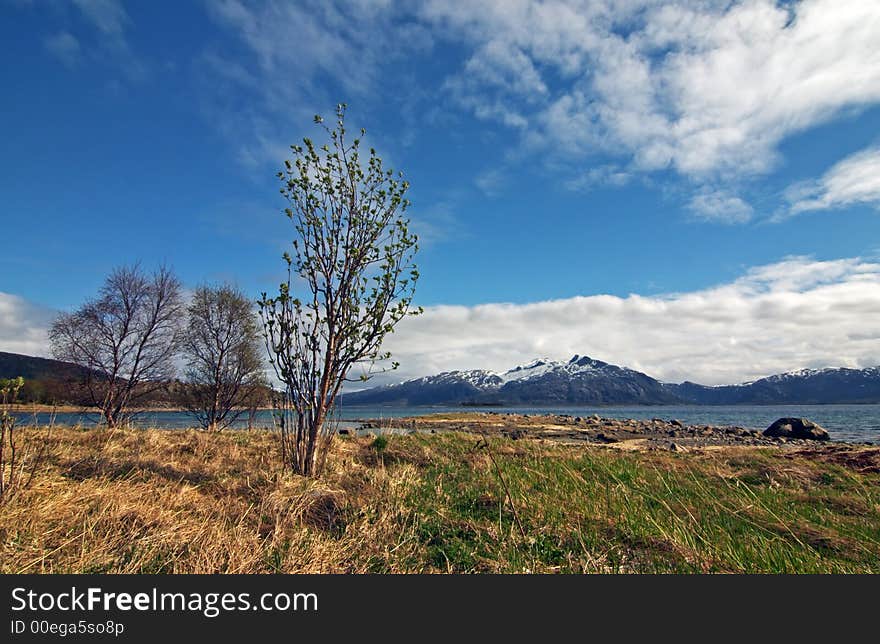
[424,0,880,184]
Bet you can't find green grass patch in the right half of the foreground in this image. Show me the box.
[387,435,880,573]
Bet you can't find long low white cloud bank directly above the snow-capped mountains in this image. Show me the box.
[360,257,880,384]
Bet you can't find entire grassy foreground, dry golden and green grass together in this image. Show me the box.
[0,428,880,573]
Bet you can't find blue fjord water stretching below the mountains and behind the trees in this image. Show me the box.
[17,405,880,443]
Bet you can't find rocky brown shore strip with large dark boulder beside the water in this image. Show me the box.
[359,412,868,451]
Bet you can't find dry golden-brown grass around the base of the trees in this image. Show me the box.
[0,428,426,573]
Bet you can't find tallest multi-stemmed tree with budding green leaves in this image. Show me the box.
[259,104,421,476]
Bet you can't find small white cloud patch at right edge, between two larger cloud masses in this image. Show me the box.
[786,147,880,215]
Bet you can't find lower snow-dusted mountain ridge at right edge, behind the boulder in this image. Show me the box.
[666,367,880,405]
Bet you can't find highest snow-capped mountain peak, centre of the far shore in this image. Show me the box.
[341,355,681,405]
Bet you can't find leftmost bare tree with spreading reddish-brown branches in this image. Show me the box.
[49,265,183,427]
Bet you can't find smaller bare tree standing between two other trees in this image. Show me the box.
[182,285,265,431]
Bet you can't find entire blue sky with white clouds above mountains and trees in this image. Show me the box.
[0,0,880,384]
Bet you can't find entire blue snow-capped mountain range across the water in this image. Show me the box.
[341,355,880,406]
